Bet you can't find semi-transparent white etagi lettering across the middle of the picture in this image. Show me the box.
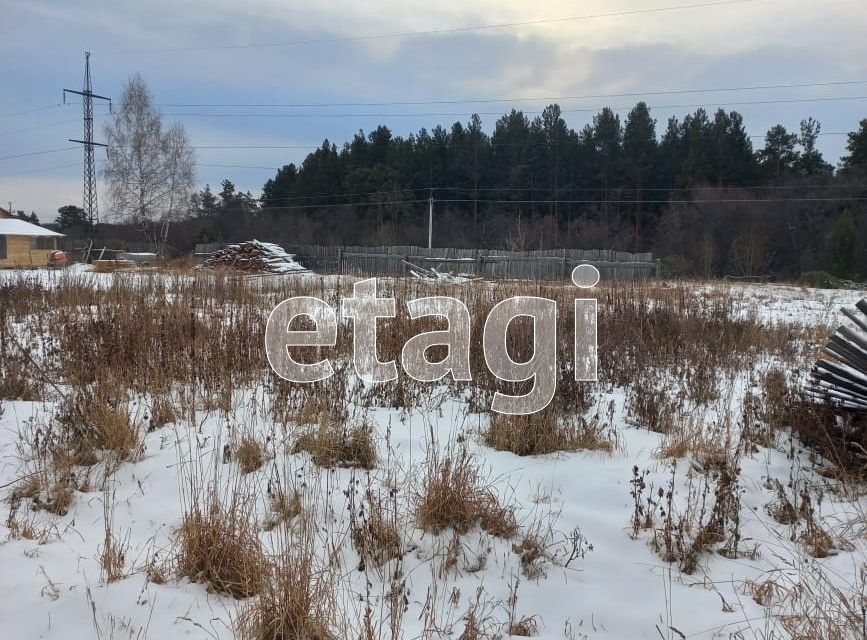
[265,264,599,415]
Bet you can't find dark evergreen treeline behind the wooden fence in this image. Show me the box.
[69,102,867,278]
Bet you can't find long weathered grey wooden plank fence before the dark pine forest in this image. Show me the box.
[285,245,659,280]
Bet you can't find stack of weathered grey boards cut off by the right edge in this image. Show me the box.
[810,299,867,413]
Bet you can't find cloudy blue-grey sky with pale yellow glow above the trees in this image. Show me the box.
[0,0,867,221]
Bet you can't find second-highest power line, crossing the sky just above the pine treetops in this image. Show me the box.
[156,80,867,109]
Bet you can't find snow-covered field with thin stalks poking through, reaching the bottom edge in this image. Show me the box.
[0,269,867,640]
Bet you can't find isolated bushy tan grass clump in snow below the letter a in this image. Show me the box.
[416,450,517,538]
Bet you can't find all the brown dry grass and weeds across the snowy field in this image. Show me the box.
[0,272,867,640]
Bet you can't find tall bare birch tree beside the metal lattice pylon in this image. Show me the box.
[102,74,196,254]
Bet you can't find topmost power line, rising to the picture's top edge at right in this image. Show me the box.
[102,0,766,55]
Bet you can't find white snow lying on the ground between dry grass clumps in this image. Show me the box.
[0,268,867,640]
